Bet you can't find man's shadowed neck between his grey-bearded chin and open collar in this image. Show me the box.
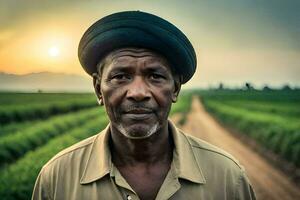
[111,123,173,166]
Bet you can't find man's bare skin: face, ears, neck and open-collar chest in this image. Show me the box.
[94,48,180,200]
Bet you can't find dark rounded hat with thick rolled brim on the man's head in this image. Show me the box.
[78,11,197,83]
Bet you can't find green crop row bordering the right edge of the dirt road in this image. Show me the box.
[202,98,300,167]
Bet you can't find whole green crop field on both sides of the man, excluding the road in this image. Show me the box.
[0,90,300,200]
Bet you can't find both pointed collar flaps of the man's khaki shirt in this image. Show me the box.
[80,120,205,184]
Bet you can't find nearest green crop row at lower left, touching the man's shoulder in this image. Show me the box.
[0,112,108,200]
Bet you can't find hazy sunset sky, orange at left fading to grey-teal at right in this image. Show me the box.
[0,0,300,88]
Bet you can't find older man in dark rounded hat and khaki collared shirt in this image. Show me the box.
[33,11,255,200]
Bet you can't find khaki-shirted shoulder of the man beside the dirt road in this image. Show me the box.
[180,131,255,199]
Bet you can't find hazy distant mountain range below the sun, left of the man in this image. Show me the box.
[0,72,93,92]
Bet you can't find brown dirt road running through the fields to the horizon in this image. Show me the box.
[173,98,300,200]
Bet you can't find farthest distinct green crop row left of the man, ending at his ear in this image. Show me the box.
[0,98,96,125]
